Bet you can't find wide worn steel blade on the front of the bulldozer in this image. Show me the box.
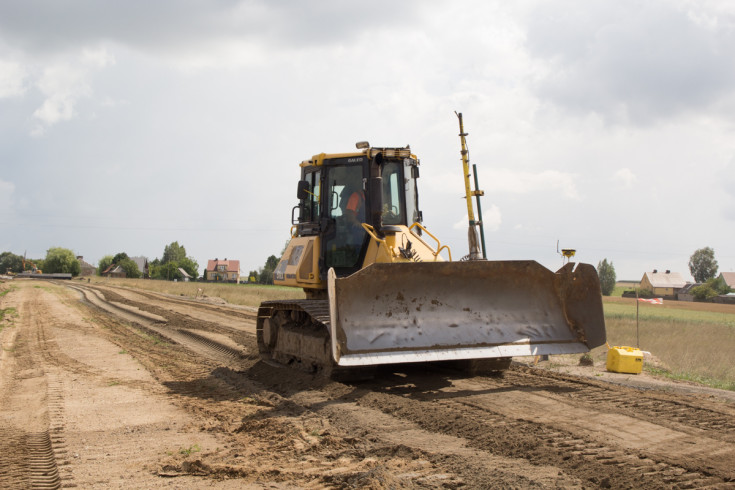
[328,261,605,366]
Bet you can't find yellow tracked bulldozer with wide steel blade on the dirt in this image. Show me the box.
[257,132,605,379]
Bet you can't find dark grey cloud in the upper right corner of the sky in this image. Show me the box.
[526,0,735,125]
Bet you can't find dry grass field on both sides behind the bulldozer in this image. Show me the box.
[80,277,735,390]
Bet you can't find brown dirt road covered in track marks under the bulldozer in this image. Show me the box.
[0,280,735,488]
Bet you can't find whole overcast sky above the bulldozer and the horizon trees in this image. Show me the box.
[0,0,735,280]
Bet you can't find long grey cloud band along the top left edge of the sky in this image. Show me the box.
[0,0,422,62]
